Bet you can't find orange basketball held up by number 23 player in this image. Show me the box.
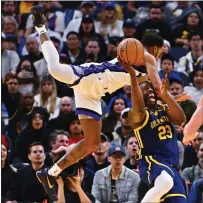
[117,38,144,65]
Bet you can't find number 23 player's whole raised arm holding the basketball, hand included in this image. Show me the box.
[118,58,146,128]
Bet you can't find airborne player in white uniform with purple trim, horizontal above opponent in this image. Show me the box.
[31,6,163,200]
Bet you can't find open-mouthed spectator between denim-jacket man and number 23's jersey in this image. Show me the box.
[124,135,139,173]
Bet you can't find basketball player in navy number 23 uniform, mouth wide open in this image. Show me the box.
[119,59,187,203]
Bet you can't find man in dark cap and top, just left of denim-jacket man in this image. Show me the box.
[86,133,110,173]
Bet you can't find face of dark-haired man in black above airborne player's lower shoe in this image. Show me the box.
[28,145,45,164]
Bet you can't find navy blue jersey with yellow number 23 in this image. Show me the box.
[134,105,179,166]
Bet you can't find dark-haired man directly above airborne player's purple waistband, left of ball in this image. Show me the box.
[85,38,104,63]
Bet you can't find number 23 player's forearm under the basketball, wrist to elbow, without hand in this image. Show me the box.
[130,71,145,122]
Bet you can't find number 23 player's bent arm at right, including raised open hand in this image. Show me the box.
[160,74,186,125]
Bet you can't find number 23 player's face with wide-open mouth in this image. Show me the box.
[140,82,157,108]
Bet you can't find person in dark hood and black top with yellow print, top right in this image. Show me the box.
[172,9,203,48]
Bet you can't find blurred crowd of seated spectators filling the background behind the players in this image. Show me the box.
[1,0,203,203]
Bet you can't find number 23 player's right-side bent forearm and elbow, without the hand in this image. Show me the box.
[162,92,186,125]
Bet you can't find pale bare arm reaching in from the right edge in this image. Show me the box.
[183,96,203,144]
